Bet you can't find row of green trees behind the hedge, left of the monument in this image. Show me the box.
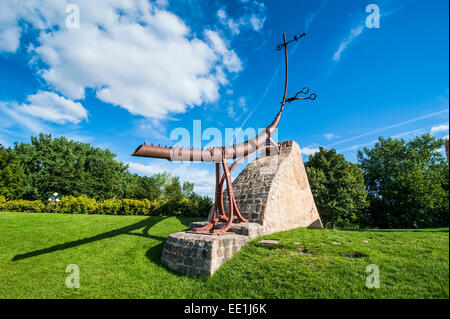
[0,134,209,208]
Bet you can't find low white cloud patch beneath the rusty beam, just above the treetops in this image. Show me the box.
[127,162,215,196]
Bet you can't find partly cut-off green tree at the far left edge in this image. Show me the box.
[0,144,24,199]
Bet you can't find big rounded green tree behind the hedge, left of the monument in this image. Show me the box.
[14,134,127,200]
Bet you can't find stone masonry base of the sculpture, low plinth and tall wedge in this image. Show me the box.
[162,141,322,276]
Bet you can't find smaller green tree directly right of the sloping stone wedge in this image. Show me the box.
[305,147,367,228]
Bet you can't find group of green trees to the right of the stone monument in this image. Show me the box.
[305,134,449,228]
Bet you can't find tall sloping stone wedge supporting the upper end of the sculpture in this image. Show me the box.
[220,141,322,233]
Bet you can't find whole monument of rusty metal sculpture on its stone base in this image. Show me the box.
[132,33,322,275]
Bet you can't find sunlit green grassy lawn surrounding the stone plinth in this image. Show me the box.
[0,212,449,298]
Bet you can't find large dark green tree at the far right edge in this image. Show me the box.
[357,134,449,228]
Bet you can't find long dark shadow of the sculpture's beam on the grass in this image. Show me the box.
[12,216,168,263]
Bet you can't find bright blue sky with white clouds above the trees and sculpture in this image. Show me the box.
[0,0,449,194]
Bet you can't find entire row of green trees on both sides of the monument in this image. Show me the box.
[0,134,449,228]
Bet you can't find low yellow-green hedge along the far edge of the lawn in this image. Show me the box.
[0,195,212,217]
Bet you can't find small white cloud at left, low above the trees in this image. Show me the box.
[17,91,87,124]
